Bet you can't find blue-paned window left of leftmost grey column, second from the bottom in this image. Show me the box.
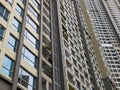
[8,35,18,52]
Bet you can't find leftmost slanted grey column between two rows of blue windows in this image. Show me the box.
[12,0,29,90]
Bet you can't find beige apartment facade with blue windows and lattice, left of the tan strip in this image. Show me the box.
[0,0,113,90]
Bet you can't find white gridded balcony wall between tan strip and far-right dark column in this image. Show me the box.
[82,0,119,90]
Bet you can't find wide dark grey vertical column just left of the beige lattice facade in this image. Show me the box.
[51,0,66,90]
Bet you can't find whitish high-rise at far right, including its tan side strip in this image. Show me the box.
[82,0,120,90]
